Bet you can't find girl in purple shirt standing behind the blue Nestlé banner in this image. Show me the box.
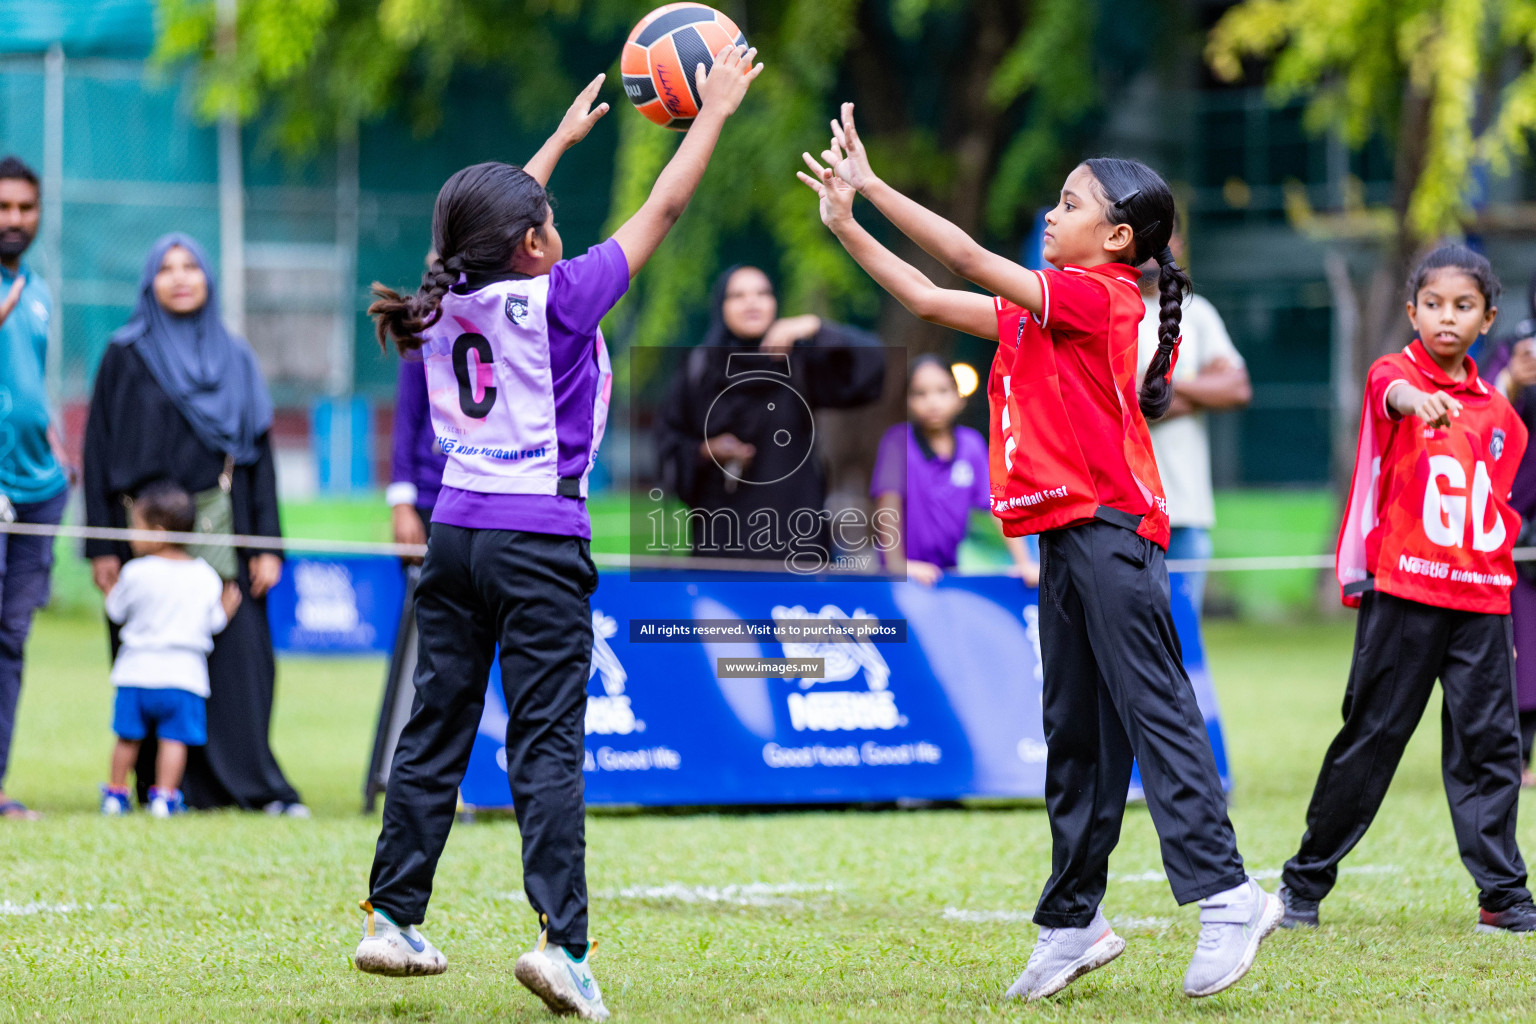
[869,355,1040,586]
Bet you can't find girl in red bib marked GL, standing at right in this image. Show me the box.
[1279,246,1536,932]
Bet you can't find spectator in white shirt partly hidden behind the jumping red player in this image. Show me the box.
[1137,232,1253,617]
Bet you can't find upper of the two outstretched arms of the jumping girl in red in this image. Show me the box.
[822,103,1044,316]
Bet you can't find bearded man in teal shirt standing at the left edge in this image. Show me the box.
[0,157,69,818]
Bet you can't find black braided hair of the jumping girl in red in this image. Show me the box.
[1086,157,1193,419]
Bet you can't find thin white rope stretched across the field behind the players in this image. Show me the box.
[0,522,1536,576]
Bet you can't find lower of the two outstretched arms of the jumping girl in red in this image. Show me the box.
[799,154,997,341]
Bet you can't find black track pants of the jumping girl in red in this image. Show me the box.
[1035,519,1247,927]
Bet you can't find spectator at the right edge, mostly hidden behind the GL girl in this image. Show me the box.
[1482,291,1536,786]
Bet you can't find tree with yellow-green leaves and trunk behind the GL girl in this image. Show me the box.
[1206,0,1536,493]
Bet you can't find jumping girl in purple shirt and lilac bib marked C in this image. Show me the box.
[347,56,762,1021]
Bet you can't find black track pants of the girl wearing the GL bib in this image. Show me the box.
[1283,593,1531,910]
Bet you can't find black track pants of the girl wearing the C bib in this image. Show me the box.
[369,524,598,946]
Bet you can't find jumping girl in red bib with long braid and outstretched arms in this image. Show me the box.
[800,104,1283,999]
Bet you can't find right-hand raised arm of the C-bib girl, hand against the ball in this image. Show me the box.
[613,46,763,279]
